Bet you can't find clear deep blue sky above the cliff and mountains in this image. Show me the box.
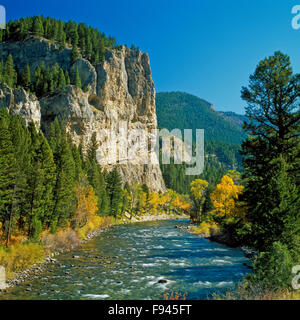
[0,0,300,113]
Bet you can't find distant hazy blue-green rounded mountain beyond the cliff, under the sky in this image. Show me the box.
[156,92,244,144]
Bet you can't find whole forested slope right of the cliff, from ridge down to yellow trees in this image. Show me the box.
[156,92,245,193]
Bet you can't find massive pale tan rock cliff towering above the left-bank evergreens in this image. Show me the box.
[0,38,165,191]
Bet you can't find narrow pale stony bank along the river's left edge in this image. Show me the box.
[0,214,189,294]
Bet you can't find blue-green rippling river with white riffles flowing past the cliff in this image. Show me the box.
[0,220,249,299]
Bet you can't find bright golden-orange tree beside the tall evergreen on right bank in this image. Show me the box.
[210,175,243,218]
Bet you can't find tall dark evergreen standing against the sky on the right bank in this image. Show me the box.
[242,52,300,251]
